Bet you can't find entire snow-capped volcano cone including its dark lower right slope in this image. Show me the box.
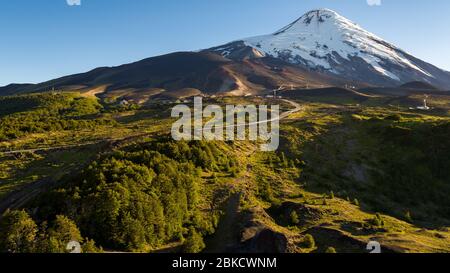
[209,9,450,87]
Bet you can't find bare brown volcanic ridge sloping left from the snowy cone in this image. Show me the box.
[0,52,342,100]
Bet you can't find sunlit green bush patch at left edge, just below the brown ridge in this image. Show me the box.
[0,93,114,141]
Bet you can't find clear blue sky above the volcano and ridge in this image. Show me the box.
[0,0,450,86]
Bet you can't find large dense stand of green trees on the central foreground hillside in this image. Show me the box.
[22,139,236,252]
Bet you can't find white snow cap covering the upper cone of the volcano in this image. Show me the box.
[245,9,431,80]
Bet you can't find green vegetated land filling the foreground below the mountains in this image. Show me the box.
[0,93,450,253]
